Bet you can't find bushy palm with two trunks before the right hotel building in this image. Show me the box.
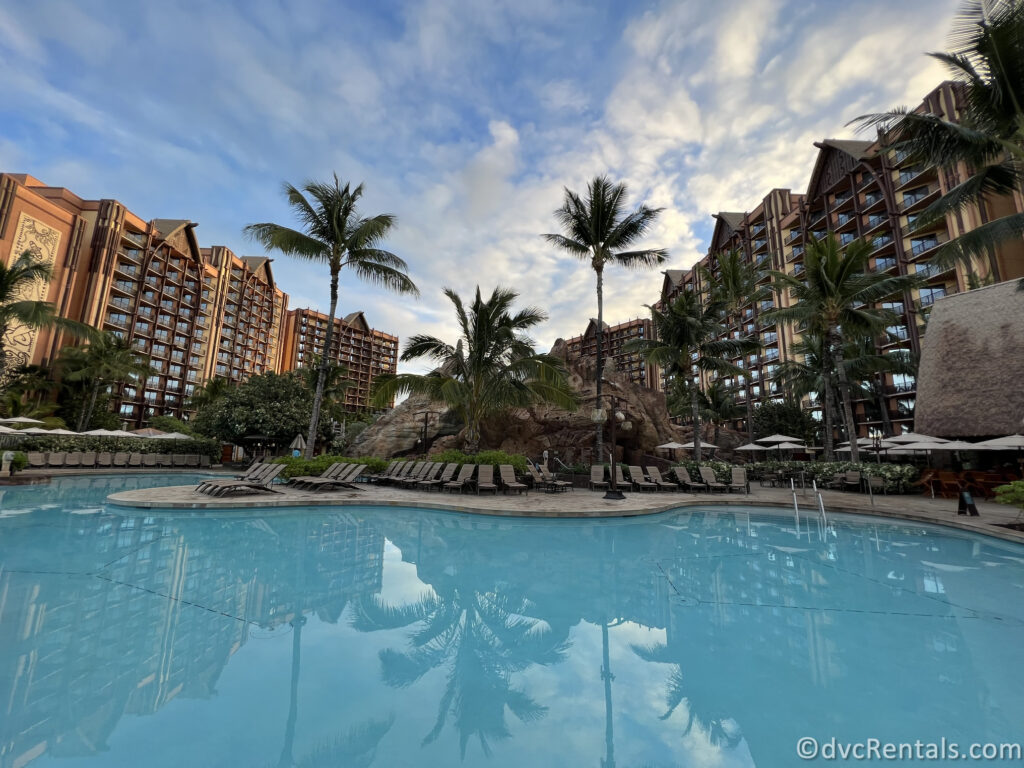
[765,232,919,462]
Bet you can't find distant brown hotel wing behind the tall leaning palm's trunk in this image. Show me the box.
[281,309,398,413]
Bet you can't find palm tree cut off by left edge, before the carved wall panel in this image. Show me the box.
[0,251,93,388]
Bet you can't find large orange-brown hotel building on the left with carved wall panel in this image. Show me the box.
[0,173,398,428]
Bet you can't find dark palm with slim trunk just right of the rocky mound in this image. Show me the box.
[627,291,760,461]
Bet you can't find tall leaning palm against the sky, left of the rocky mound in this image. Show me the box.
[245,174,419,458]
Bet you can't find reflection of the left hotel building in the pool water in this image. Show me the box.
[0,514,384,768]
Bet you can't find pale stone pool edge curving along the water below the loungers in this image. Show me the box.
[106,485,1024,544]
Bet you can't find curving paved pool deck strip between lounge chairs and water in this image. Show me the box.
[106,483,1024,543]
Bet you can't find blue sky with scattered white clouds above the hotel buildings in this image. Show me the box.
[0,0,957,371]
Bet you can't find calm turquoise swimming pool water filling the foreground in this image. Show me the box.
[0,475,1024,768]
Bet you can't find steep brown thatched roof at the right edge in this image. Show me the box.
[913,281,1024,437]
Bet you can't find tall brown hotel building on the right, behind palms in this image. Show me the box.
[659,83,1024,436]
